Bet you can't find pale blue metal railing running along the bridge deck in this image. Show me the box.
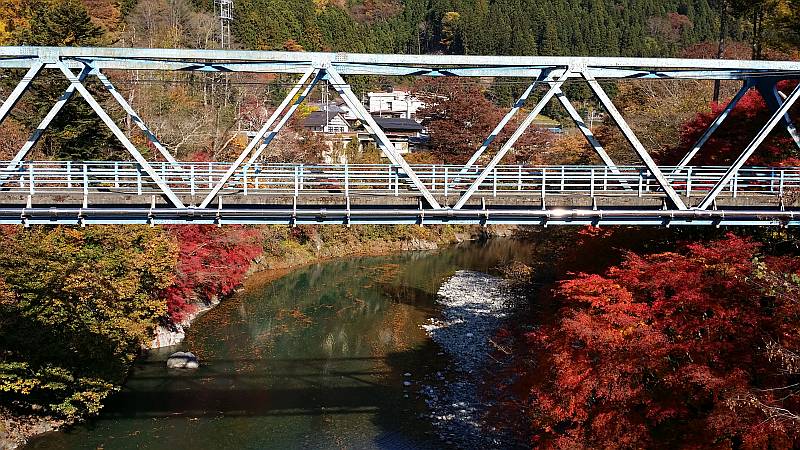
[0,161,800,197]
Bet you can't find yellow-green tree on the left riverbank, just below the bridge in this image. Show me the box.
[0,227,177,418]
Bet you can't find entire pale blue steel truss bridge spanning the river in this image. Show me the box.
[0,47,800,226]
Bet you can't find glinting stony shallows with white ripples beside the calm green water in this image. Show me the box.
[420,270,518,448]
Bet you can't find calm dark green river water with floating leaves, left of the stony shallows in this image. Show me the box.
[28,240,532,449]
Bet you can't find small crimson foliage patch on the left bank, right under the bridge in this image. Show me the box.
[164,225,263,323]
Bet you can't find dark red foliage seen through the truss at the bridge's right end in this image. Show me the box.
[665,82,800,166]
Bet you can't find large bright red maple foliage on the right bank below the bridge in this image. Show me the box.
[496,235,800,449]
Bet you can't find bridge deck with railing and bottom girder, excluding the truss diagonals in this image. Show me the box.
[0,161,800,225]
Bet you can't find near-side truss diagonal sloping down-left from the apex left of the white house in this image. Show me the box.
[199,67,323,209]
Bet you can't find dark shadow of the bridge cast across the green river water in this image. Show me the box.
[87,342,447,449]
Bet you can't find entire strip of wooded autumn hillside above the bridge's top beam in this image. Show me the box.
[0,0,797,56]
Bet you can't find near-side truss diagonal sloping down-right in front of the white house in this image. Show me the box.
[326,66,442,209]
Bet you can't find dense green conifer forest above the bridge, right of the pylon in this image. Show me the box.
[227,0,724,56]
